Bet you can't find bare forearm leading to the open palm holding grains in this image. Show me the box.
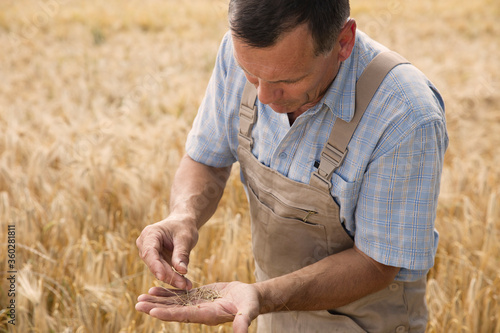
[255,248,399,314]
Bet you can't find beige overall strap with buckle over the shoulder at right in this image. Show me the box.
[310,51,409,189]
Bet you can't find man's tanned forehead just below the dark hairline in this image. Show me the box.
[233,25,316,81]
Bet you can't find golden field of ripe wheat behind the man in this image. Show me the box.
[0,0,500,333]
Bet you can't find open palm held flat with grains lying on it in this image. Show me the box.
[135,282,260,333]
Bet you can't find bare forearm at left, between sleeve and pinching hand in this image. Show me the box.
[170,155,231,229]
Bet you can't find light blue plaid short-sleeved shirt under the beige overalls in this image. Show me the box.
[186,30,448,281]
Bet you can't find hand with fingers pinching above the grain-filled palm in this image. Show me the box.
[136,215,198,289]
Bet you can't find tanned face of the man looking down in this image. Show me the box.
[233,20,355,118]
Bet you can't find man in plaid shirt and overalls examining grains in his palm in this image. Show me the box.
[136,0,448,332]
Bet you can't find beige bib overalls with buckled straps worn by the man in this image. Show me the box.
[238,52,427,333]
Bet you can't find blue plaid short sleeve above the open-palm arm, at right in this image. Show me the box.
[355,120,447,280]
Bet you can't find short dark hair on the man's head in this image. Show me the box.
[229,0,350,54]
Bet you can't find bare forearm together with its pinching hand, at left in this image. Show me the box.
[136,155,231,289]
